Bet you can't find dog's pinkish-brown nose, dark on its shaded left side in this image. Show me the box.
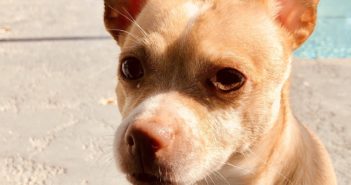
[125,121,174,163]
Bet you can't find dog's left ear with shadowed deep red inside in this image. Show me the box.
[104,0,147,45]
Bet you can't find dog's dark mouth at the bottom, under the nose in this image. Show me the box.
[128,173,174,185]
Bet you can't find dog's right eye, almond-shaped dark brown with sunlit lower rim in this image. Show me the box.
[210,68,245,93]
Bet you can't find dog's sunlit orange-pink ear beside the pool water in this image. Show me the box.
[264,0,319,49]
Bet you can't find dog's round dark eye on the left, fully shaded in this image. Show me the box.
[121,57,144,80]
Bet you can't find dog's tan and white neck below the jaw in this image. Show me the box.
[216,81,326,185]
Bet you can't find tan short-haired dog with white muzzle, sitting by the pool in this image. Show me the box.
[104,0,336,185]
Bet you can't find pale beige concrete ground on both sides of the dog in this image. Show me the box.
[0,0,351,185]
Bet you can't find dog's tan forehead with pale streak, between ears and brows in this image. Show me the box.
[126,0,288,80]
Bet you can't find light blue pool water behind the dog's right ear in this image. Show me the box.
[295,0,351,59]
